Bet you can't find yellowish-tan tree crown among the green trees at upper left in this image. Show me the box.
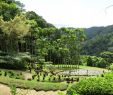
[0,15,29,37]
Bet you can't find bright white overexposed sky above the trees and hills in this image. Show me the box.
[19,0,113,28]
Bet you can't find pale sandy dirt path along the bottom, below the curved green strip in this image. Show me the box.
[0,84,65,95]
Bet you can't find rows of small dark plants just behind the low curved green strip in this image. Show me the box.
[0,70,79,83]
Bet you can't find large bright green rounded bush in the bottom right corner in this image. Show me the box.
[67,77,113,95]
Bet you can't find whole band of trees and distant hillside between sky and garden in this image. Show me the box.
[0,0,113,69]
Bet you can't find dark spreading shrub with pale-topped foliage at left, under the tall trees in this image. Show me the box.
[0,52,31,70]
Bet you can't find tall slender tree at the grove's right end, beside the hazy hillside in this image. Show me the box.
[61,28,85,65]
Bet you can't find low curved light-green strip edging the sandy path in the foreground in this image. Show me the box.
[0,76,68,91]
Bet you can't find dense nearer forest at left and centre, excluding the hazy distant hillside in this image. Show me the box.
[0,0,85,69]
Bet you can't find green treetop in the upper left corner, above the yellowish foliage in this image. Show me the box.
[0,0,23,21]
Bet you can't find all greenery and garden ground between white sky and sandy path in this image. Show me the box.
[0,0,113,95]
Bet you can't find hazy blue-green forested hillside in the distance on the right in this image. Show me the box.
[82,25,113,55]
